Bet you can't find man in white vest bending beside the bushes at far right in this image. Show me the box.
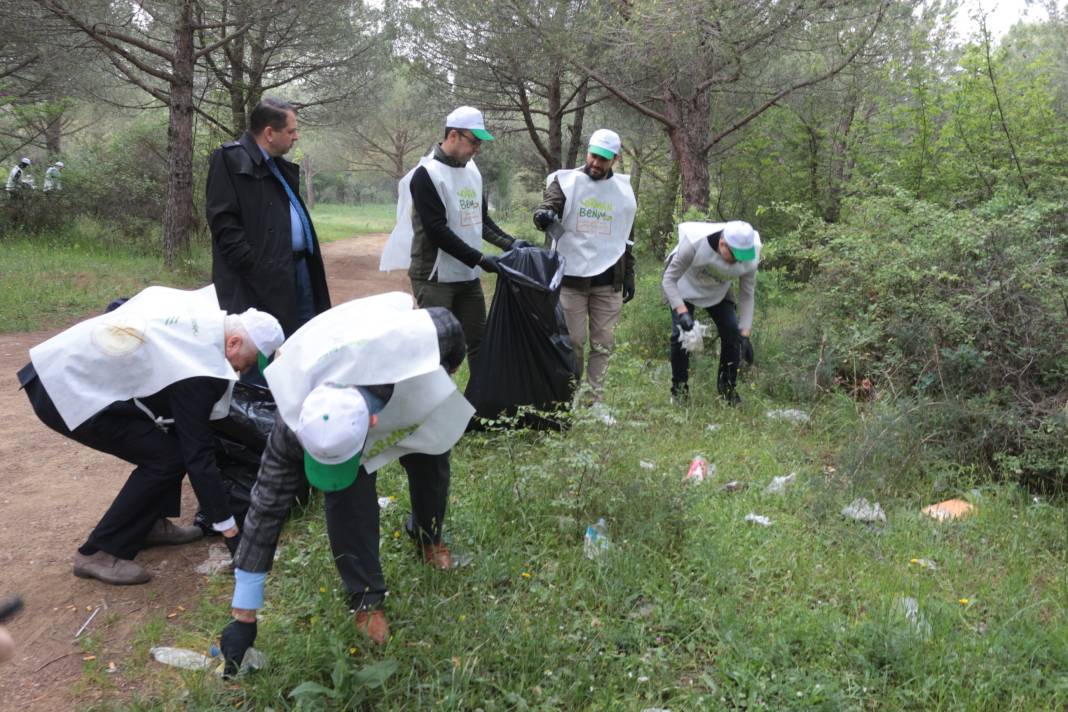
[660,220,763,406]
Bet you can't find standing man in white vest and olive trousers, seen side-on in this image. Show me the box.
[379,107,527,370]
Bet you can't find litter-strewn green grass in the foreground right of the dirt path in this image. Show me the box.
[98,271,1068,711]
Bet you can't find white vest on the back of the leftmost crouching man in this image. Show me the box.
[30,286,237,430]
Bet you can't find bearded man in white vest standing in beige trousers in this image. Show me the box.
[534,128,638,405]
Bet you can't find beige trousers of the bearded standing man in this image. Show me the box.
[560,284,623,401]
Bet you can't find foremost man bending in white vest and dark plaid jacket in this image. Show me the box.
[220,292,474,674]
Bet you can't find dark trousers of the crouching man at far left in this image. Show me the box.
[25,377,186,559]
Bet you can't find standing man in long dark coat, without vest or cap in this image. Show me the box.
[205,98,330,345]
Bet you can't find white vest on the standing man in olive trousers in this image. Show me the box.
[378,153,482,282]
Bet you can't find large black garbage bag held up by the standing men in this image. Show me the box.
[464,248,578,429]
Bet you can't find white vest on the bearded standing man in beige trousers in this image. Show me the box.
[546,169,638,276]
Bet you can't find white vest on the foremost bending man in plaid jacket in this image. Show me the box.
[264,291,474,472]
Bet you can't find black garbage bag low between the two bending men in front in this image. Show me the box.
[193,381,308,534]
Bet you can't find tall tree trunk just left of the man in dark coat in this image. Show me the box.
[163,0,193,268]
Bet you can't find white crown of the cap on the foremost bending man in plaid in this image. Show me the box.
[297,383,371,464]
